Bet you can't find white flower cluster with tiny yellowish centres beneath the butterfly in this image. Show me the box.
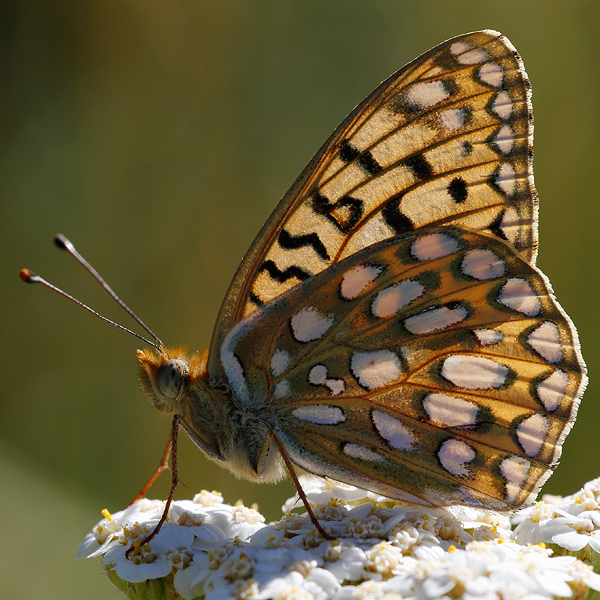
[79,479,600,600]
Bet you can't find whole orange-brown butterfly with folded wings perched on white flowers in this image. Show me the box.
[22,31,586,540]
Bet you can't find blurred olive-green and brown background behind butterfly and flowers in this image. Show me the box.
[0,0,600,600]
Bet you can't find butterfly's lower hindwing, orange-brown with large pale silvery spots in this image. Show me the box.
[221,227,585,510]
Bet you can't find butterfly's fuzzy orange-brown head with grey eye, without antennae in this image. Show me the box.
[137,347,208,414]
